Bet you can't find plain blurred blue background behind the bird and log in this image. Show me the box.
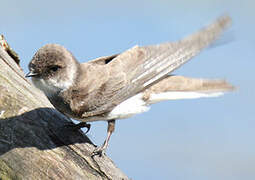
[0,0,255,180]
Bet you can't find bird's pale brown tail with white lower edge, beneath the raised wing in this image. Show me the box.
[144,76,234,104]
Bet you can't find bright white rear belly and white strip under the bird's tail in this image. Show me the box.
[107,91,223,119]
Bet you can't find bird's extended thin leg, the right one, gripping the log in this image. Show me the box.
[92,120,115,156]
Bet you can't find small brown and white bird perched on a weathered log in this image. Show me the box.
[26,15,234,156]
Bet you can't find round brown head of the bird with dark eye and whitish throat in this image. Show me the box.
[26,44,79,97]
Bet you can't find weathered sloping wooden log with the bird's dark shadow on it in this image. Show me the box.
[0,38,128,180]
